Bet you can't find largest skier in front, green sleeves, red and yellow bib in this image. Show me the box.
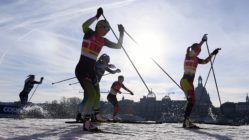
[75,8,124,131]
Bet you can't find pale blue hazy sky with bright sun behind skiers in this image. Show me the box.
[0,0,249,106]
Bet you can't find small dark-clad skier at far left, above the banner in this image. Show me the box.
[19,75,43,105]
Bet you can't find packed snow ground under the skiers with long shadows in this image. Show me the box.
[0,118,249,140]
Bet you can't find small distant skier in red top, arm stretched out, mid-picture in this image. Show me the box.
[107,75,134,121]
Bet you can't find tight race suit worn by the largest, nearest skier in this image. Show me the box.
[75,17,120,119]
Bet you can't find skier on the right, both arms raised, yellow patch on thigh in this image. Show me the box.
[180,34,220,128]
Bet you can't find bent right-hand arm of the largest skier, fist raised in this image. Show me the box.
[105,24,124,49]
